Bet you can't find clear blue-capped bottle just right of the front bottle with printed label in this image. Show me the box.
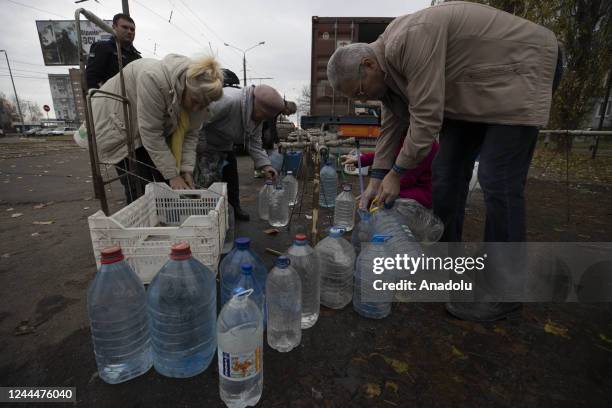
[266,256,302,352]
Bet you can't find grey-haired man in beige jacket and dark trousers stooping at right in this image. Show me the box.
[327,2,560,320]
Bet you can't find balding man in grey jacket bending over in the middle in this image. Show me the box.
[195,85,285,221]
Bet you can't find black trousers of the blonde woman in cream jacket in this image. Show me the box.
[116,147,166,204]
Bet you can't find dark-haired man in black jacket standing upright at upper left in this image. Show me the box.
[86,13,142,89]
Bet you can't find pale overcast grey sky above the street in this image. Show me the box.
[0,0,431,117]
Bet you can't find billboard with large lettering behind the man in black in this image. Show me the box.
[36,20,112,65]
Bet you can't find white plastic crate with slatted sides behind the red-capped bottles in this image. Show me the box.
[88,183,228,283]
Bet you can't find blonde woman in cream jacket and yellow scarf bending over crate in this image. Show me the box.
[92,54,223,203]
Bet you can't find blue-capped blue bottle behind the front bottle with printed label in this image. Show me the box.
[219,237,268,306]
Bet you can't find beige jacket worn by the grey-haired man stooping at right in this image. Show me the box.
[371,2,558,169]
